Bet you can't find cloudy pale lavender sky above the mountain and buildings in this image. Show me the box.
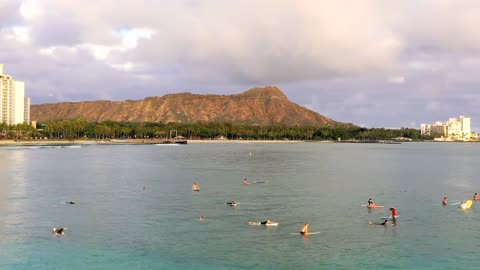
[0,0,480,131]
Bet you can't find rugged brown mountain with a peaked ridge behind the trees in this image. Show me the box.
[31,86,344,126]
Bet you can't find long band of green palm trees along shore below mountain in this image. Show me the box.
[0,118,431,141]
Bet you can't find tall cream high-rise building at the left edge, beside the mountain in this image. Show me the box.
[0,64,30,125]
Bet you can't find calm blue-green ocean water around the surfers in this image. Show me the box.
[0,143,480,270]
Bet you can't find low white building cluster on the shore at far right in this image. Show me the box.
[420,115,472,140]
